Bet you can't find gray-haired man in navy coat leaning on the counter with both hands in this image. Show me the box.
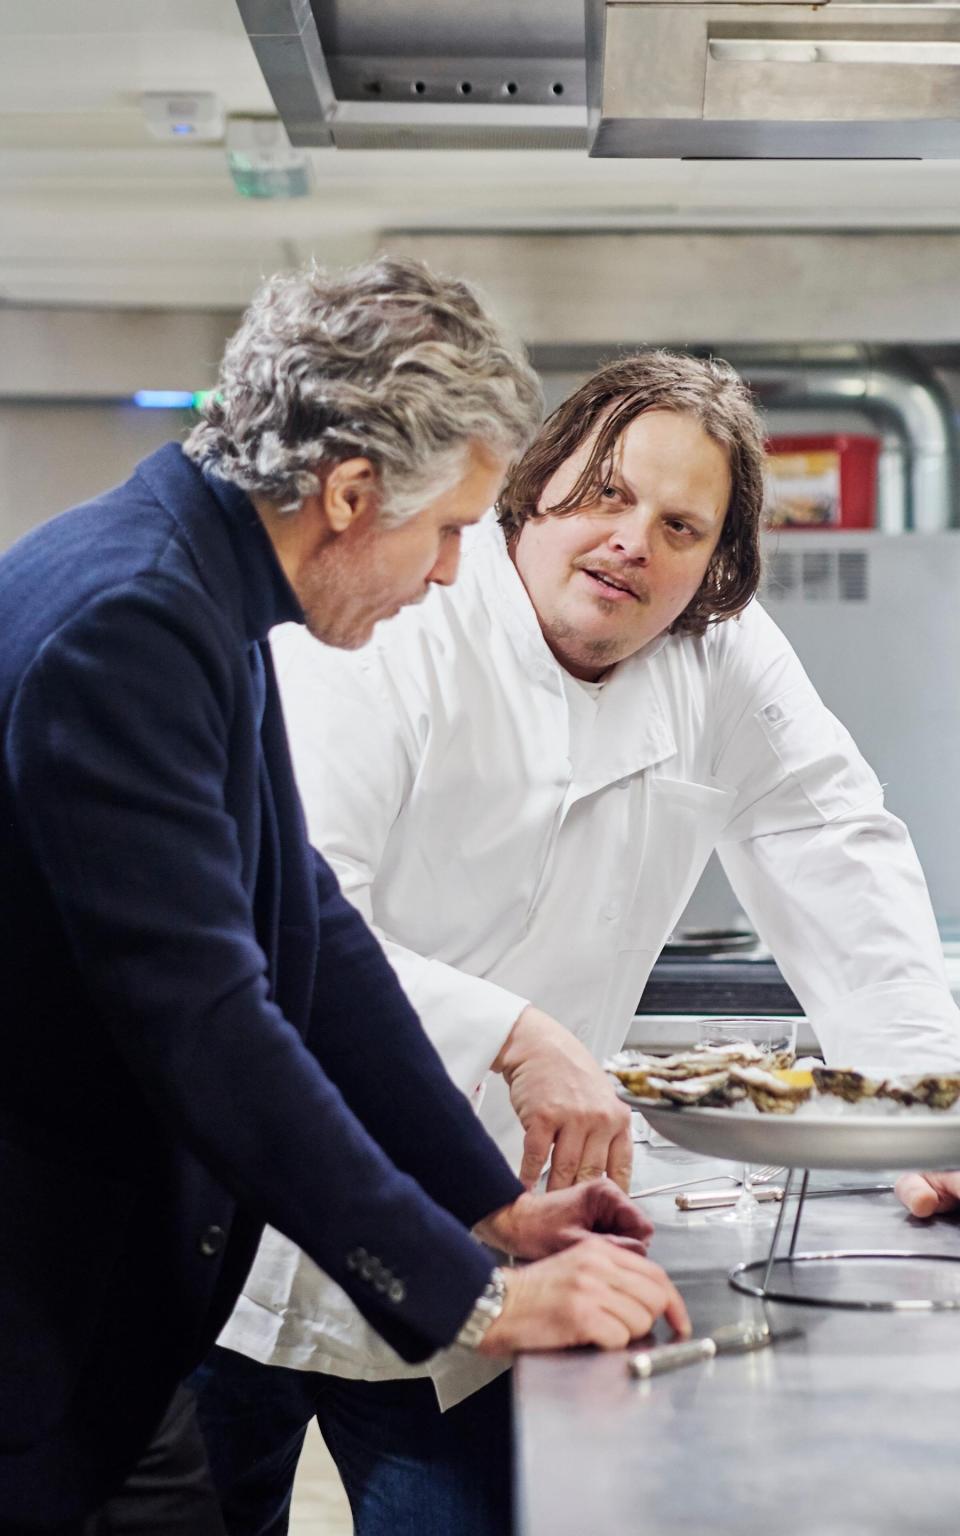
[0,261,685,1536]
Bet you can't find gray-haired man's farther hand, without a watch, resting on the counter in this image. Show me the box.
[473,1178,653,1258]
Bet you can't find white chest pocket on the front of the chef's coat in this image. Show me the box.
[622,774,737,955]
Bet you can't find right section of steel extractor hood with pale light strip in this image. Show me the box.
[587,0,960,160]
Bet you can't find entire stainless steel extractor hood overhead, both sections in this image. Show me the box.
[237,0,960,160]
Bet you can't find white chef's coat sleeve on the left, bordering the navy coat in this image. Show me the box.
[270,625,528,1097]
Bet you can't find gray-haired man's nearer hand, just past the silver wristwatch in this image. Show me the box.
[479,1238,690,1355]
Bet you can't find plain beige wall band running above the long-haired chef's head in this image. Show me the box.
[382,230,960,346]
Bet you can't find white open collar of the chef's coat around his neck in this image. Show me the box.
[478,513,677,799]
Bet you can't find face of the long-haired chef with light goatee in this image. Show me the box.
[511,410,731,680]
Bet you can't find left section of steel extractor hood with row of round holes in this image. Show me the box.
[237,0,587,149]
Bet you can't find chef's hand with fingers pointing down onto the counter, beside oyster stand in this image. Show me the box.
[493,1005,633,1190]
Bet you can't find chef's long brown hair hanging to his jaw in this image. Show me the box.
[496,350,763,634]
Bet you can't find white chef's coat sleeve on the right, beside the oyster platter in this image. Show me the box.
[703,604,960,1074]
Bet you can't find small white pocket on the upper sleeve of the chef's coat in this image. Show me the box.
[754,684,880,822]
